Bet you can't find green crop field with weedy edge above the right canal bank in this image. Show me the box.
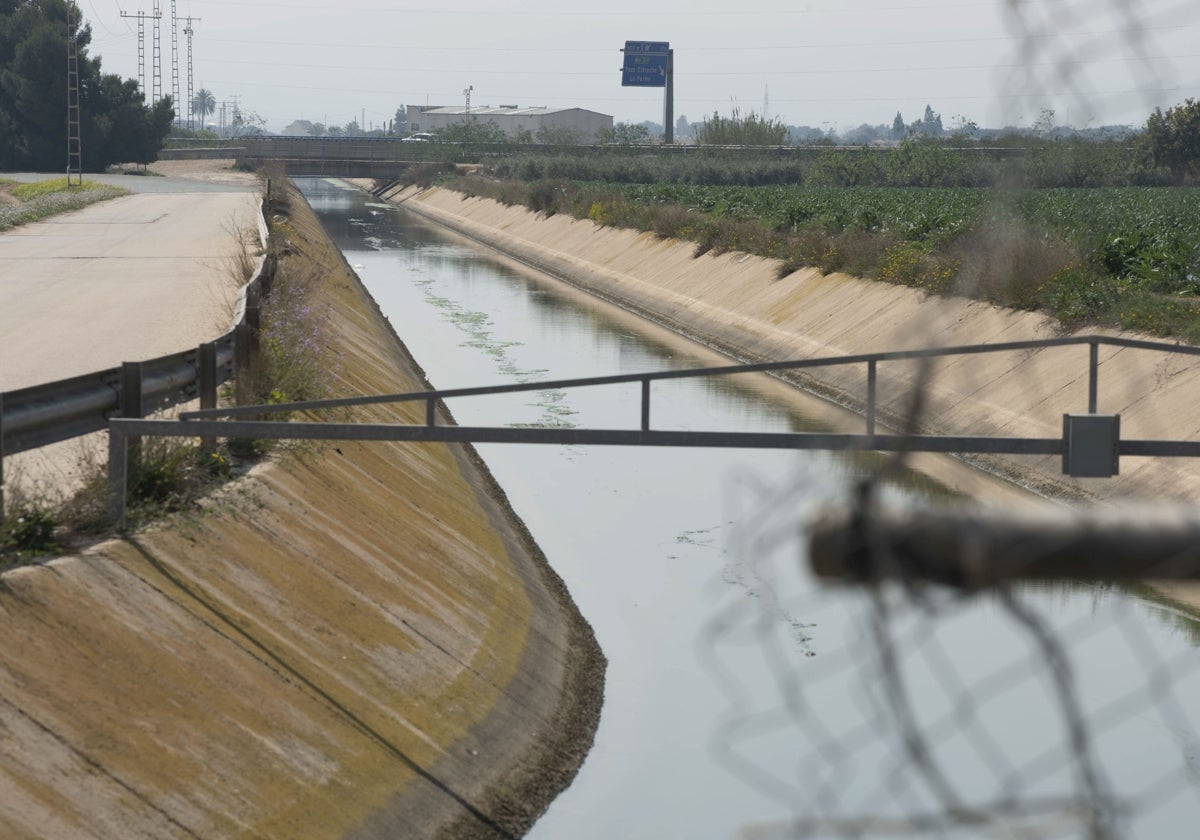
[448,175,1200,343]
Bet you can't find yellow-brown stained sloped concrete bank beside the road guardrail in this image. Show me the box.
[0,180,604,840]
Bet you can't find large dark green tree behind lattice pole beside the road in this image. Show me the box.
[0,0,174,172]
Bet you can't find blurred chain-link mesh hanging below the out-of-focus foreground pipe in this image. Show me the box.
[700,458,1200,840]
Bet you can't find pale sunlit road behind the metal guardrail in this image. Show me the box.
[0,174,258,391]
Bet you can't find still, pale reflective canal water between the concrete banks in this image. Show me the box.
[300,179,1200,840]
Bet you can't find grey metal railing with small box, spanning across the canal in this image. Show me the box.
[109,336,1200,524]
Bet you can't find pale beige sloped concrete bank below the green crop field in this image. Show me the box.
[388,188,1200,500]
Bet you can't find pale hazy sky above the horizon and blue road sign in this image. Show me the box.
[79,0,1200,131]
